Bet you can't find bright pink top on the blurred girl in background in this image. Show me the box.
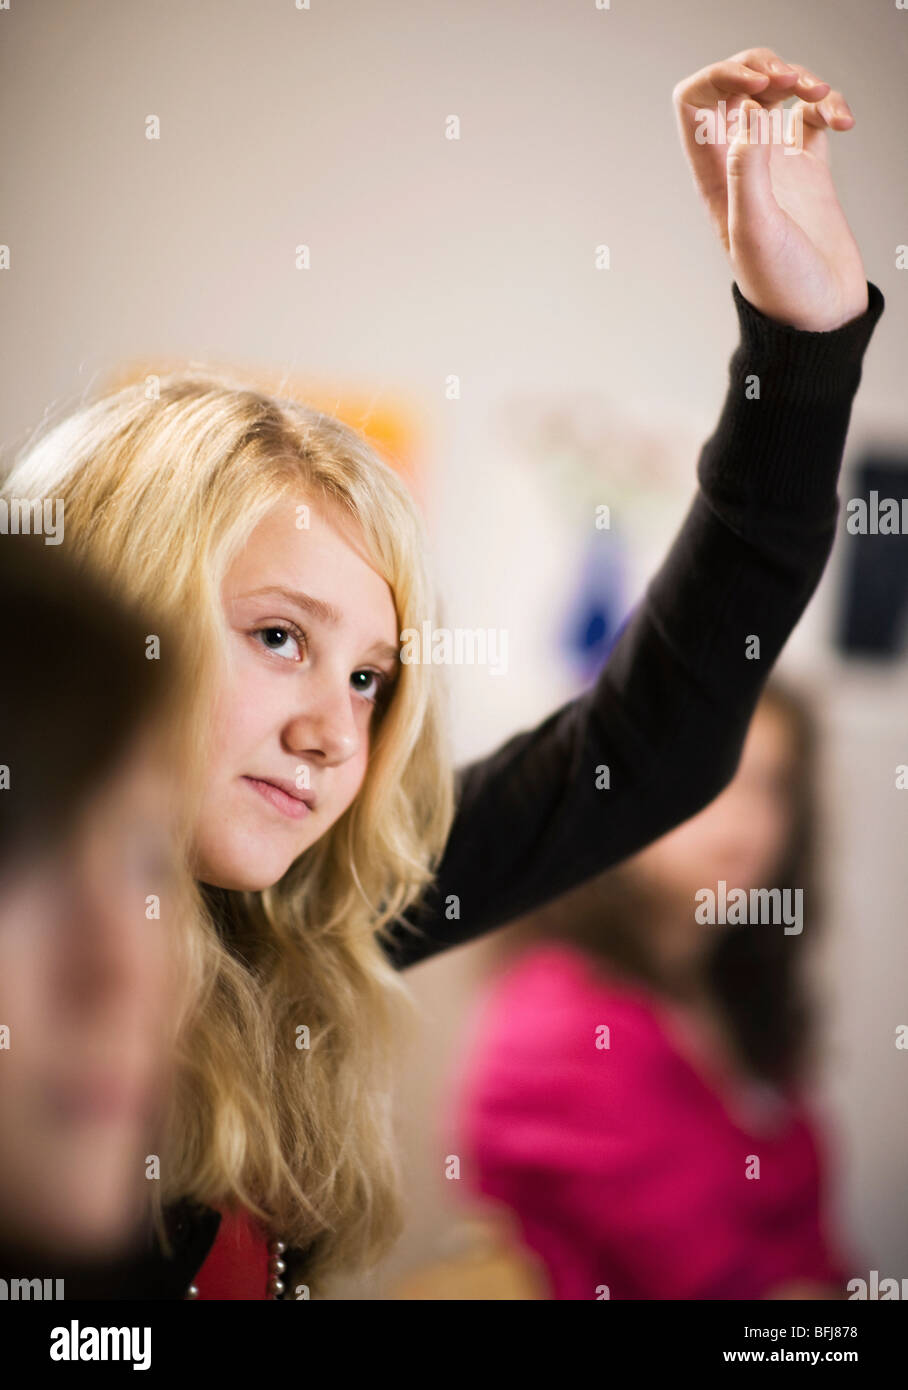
[455,942,857,1300]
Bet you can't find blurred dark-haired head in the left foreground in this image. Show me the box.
[0,535,189,1259]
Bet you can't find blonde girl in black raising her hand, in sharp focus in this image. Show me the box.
[4,49,883,1297]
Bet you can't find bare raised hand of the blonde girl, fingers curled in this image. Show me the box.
[673,49,868,331]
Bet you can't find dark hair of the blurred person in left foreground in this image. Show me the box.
[0,535,171,860]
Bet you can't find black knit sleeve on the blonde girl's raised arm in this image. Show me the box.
[384,285,884,967]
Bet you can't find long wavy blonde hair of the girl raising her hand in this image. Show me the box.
[3,371,453,1282]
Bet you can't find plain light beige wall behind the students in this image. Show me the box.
[0,0,908,1295]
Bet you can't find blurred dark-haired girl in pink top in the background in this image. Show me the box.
[455,685,845,1298]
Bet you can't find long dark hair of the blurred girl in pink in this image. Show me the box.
[501,681,822,1084]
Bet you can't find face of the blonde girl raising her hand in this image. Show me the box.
[195,499,400,891]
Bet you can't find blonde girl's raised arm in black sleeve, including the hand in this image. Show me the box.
[387,49,883,967]
